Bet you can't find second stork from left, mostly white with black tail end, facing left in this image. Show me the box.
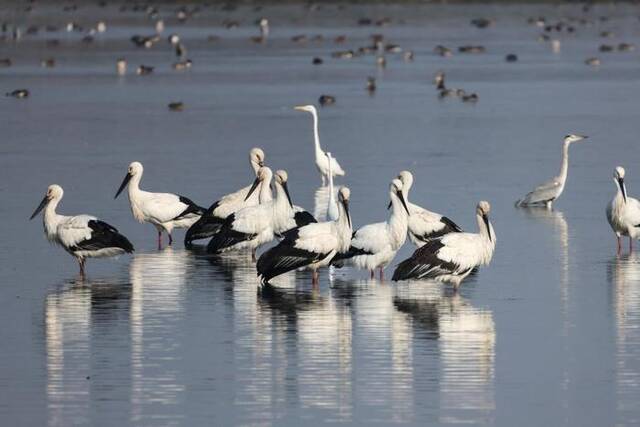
[114,162,205,249]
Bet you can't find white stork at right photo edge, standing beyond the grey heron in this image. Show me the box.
[607,166,640,254]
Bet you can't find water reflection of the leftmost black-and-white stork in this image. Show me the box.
[44,278,131,425]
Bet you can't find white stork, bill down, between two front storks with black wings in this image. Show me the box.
[333,179,409,280]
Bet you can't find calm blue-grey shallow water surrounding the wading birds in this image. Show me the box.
[0,5,640,426]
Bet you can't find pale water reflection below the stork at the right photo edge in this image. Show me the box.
[607,253,640,421]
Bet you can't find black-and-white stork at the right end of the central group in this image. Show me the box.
[392,201,496,289]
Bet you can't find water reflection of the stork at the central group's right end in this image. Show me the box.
[393,281,496,424]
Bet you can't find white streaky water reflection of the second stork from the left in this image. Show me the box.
[129,247,192,423]
